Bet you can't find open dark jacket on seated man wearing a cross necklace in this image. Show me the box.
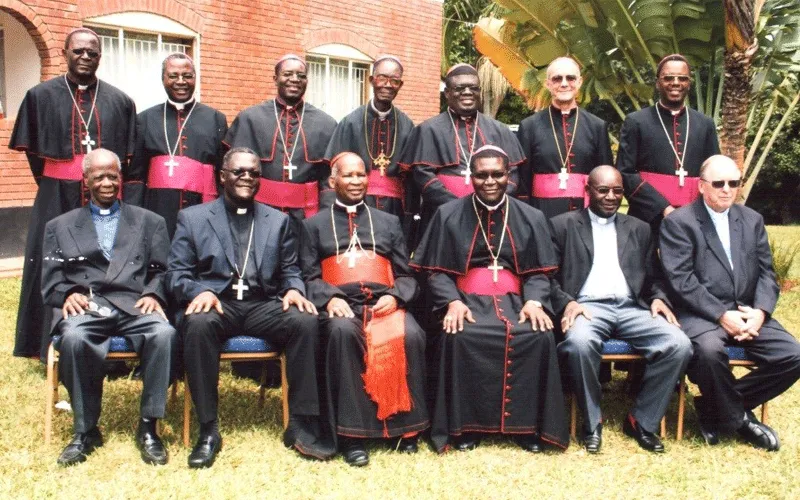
[167,197,305,305]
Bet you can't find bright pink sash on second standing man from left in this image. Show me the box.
[147,155,217,203]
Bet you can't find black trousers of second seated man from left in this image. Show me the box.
[181,299,319,423]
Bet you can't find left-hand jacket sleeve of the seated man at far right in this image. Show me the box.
[659,214,727,323]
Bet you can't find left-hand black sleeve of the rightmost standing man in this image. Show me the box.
[617,119,669,223]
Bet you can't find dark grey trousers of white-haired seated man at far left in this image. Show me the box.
[55,310,176,432]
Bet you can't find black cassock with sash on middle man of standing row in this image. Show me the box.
[325,102,414,221]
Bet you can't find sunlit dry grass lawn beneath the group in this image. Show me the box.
[0,228,800,499]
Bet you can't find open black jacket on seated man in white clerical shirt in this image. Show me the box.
[551,208,669,314]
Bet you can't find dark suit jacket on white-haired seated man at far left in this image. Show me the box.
[42,203,169,334]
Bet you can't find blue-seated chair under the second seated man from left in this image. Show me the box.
[183,335,289,446]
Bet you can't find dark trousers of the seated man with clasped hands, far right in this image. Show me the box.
[686,319,800,432]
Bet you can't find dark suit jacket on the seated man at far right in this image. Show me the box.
[660,198,780,337]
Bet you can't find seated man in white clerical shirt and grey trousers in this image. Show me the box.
[551,165,692,453]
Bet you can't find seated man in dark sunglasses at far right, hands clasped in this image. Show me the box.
[659,155,800,451]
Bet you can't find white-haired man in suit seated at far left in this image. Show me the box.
[42,149,175,466]
